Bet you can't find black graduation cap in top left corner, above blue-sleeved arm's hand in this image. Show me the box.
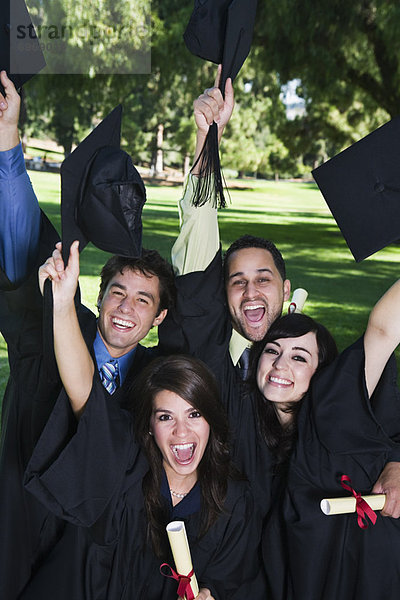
[0,0,46,94]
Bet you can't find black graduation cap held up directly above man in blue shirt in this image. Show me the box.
[61,105,146,264]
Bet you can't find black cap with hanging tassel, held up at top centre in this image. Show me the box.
[183,0,257,206]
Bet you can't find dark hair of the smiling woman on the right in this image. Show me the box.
[248,313,338,467]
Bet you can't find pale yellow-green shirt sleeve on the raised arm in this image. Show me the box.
[171,175,219,275]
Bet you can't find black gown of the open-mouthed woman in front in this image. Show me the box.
[21,382,265,600]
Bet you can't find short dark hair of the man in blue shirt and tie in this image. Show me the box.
[99,248,176,313]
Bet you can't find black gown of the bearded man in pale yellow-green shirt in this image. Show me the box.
[159,250,278,515]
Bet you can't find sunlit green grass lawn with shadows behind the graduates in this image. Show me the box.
[0,172,400,395]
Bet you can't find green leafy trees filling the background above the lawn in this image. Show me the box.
[21,0,400,177]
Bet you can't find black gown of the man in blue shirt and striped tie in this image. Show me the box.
[0,213,159,600]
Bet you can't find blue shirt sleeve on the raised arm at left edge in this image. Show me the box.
[0,144,40,283]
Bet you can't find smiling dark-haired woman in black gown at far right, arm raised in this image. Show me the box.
[250,300,400,600]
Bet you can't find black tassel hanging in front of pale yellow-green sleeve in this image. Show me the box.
[191,123,229,208]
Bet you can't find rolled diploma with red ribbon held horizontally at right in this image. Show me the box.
[320,475,386,529]
